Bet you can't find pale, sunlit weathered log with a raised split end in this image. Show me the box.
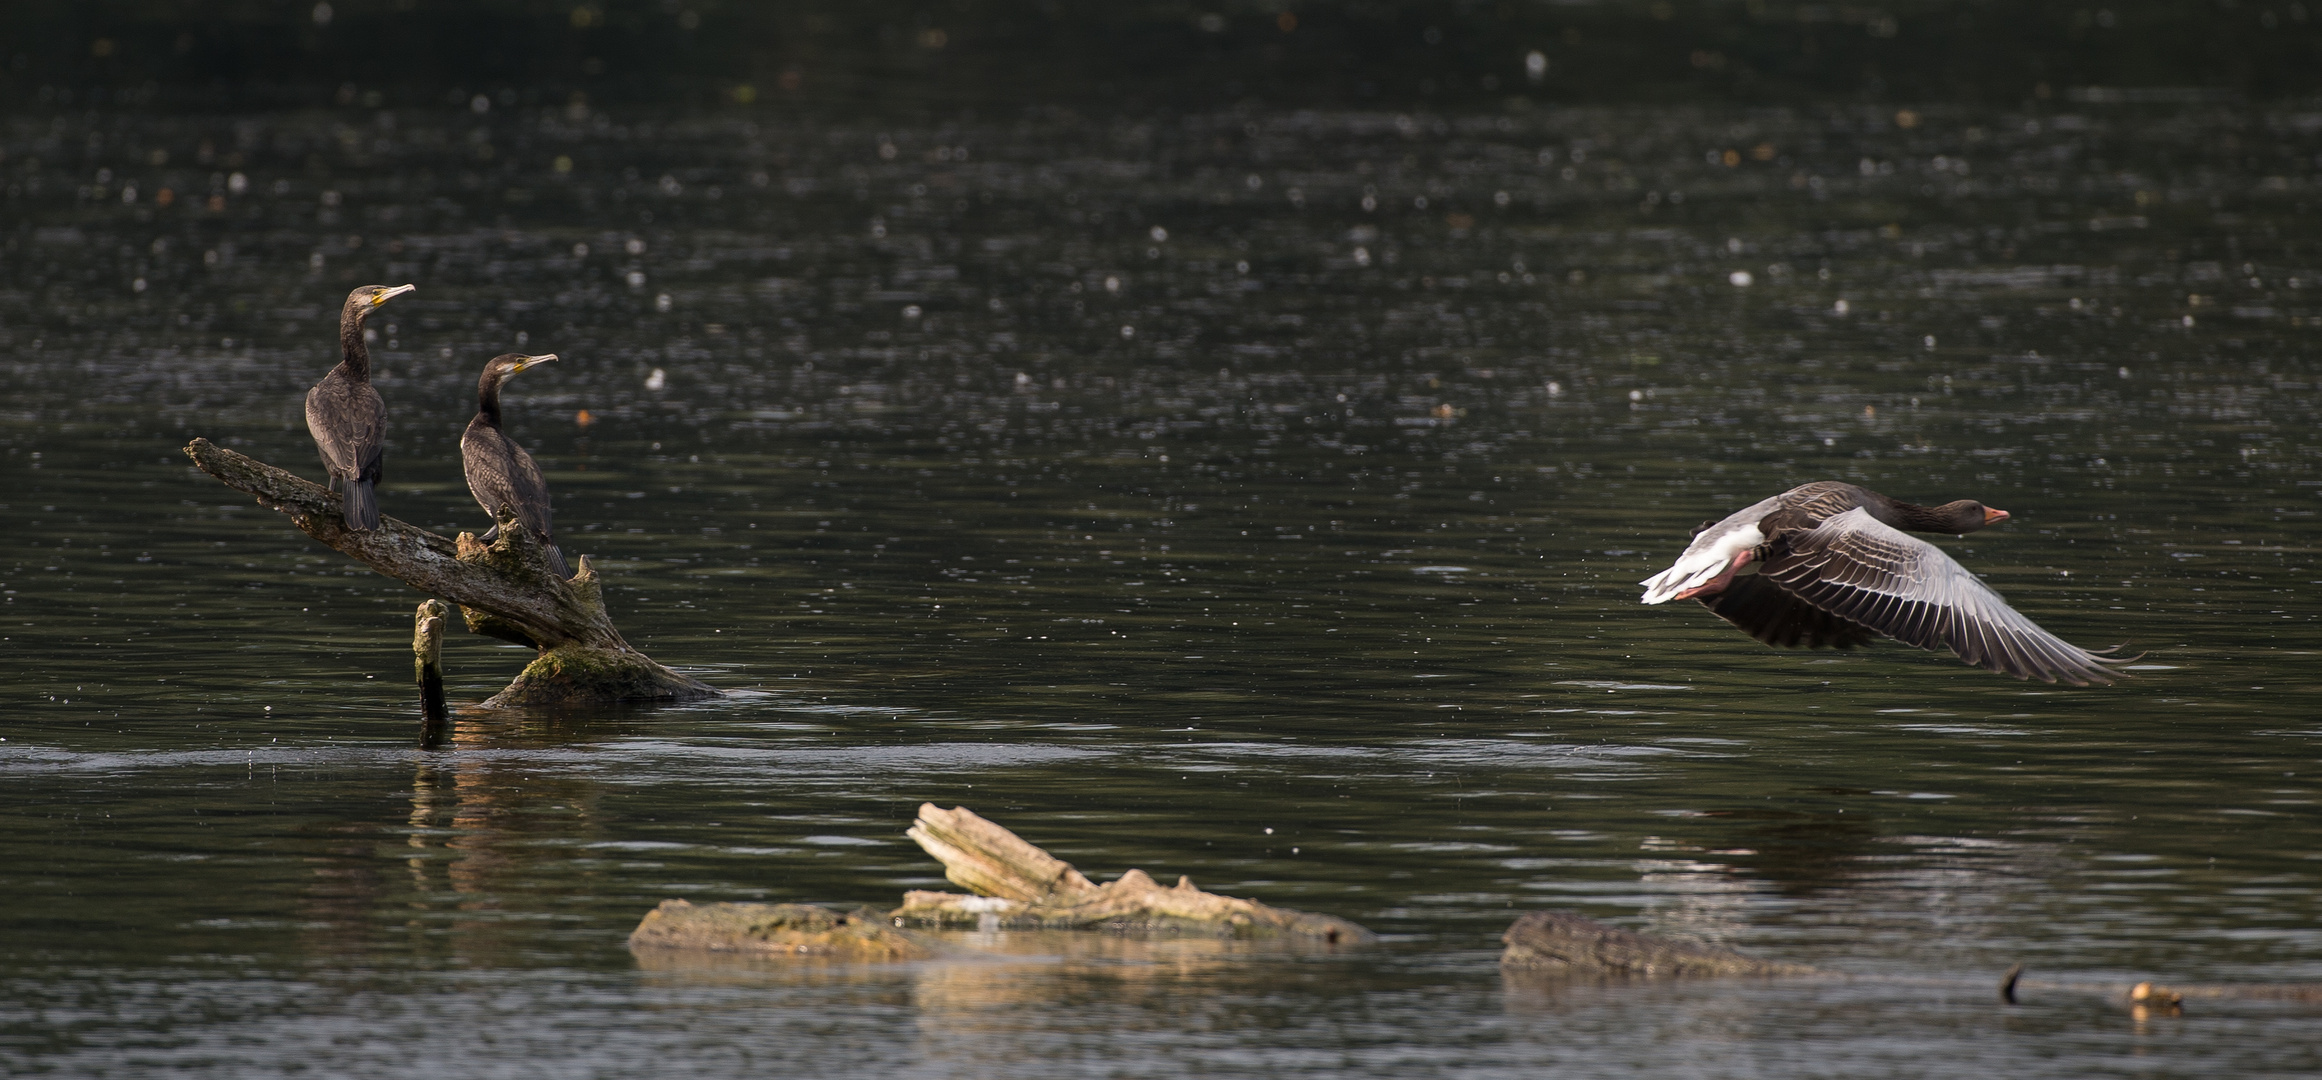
[892,804,1377,943]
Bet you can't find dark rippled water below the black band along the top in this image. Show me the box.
[0,96,2322,1078]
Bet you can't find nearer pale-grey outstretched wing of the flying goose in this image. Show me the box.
[1744,509,2127,685]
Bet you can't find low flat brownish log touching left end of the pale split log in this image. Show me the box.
[629,899,933,959]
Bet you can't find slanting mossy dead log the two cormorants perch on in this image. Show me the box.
[186,439,720,708]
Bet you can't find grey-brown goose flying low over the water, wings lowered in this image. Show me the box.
[1642,481,2127,685]
